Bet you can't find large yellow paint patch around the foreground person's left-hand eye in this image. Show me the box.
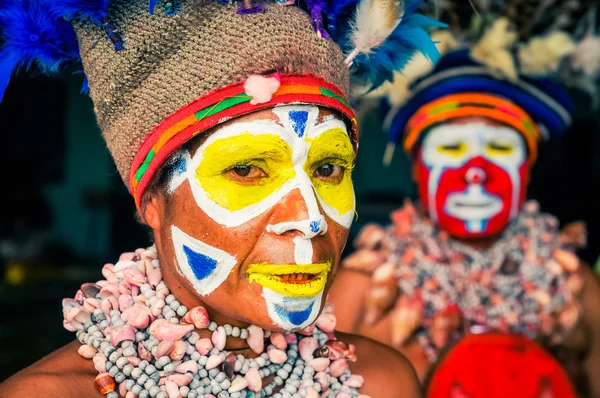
[196,133,295,211]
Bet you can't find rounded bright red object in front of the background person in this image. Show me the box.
[426,333,576,398]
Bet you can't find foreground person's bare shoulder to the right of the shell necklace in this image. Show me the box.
[339,333,421,398]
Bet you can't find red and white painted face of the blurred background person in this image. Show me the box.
[416,120,529,238]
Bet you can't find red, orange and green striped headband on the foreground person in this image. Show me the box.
[129,76,358,209]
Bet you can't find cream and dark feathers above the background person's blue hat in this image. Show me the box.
[371,0,600,106]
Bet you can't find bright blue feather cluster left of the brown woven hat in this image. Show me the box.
[0,0,79,100]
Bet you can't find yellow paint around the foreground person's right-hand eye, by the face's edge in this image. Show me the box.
[304,128,355,215]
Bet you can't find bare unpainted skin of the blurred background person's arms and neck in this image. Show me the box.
[329,118,600,397]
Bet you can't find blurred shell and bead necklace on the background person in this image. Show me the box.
[344,201,581,361]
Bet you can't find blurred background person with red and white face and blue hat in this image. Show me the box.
[331,50,600,397]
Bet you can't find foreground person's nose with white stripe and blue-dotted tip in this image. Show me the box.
[267,186,327,239]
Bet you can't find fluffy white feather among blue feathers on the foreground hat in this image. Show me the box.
[346,0,403,65]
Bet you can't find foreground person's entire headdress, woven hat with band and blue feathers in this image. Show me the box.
[0,0,437,205]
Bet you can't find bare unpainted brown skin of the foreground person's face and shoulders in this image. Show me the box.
[0,109,420,398]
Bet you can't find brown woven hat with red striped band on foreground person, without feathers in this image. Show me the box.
[76,0,353,205]
